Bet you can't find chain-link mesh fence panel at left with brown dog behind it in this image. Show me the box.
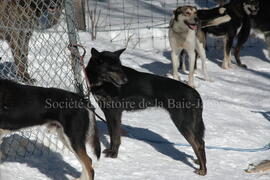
[0,0,84,159]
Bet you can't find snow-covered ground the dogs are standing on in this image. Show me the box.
[0,30,270,180]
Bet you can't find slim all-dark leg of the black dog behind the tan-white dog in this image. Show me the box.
[234,17,251,68]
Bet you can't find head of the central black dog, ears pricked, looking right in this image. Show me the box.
[86,48,128,87]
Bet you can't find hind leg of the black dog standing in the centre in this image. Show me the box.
[170,111,207,176]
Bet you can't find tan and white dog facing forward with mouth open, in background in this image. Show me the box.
[169,6,230,87]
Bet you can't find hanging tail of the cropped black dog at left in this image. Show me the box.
[88,110,101,159]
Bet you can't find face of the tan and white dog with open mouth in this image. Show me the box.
[173,6,199,30]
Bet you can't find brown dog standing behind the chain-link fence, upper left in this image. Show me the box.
[0,0,64,82]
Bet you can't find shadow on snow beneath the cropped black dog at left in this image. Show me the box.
[0,134,81,180]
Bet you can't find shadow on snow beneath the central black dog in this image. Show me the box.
[97,121,195,169]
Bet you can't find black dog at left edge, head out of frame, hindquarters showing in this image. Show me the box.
[0,79,100,180]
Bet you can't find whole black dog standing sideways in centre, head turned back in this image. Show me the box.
[86,48,207,175]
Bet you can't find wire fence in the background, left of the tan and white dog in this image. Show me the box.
[86,0,260,49]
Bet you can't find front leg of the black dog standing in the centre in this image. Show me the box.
[103,109,122,158]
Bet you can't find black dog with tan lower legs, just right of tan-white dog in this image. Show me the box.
[198,0,259,69]
